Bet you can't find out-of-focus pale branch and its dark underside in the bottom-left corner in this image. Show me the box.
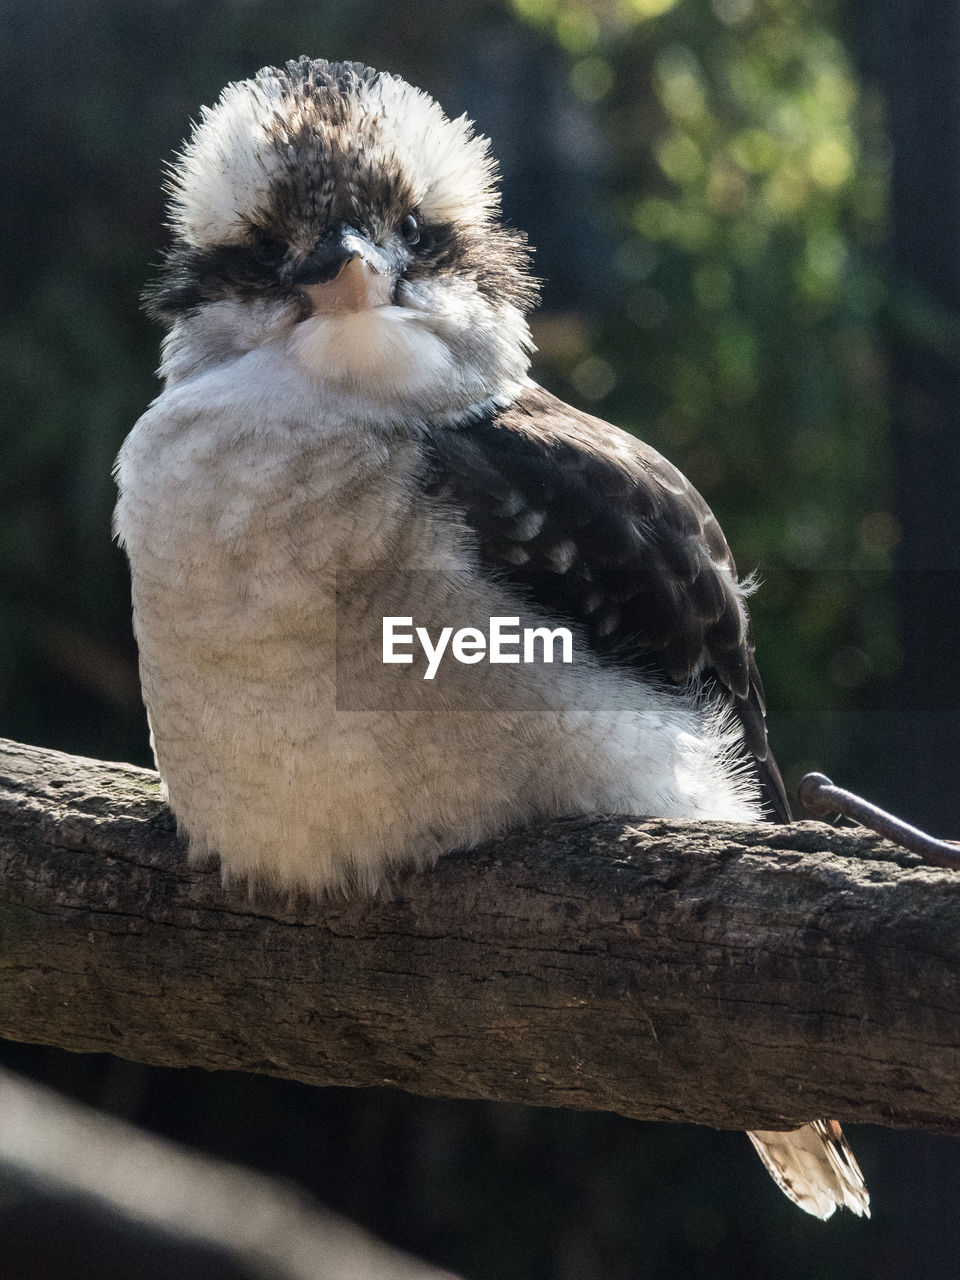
[0,1071,457,1280]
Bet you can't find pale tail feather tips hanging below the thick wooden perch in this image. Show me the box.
[748,1120,870,1220]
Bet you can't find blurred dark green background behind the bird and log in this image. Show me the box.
[0,0,960,1280]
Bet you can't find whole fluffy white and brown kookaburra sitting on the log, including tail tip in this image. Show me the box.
[116,59,868,1217]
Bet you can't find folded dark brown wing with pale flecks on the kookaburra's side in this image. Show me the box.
[425,388,790,822]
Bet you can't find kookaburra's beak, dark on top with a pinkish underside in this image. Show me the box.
[293,223,397,315]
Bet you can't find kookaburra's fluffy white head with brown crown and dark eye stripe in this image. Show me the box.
[147,58,535,416]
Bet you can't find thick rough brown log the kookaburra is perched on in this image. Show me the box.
[0,742,960,1133]
